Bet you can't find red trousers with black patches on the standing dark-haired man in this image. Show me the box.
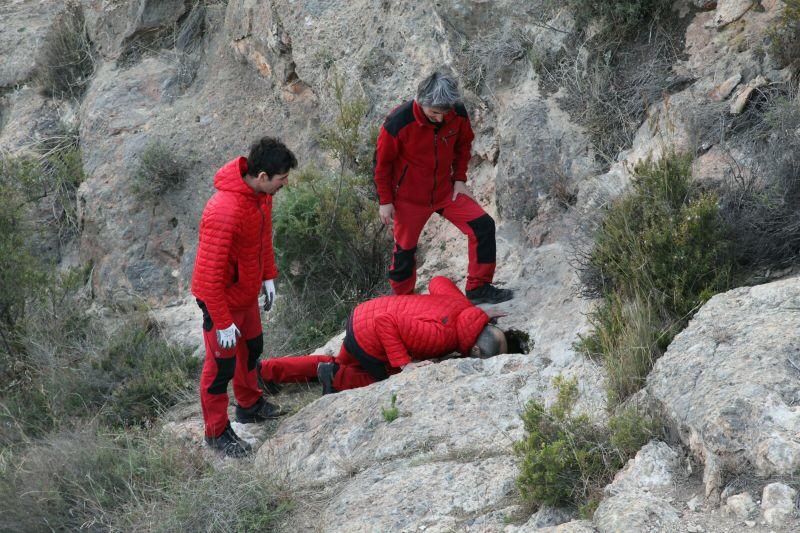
[200,302,264,437]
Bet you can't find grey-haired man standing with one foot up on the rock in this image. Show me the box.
[375,71,513,304]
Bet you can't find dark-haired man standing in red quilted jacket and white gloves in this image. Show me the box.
[192,137,297,457]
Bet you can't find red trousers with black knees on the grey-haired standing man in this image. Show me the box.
[389,194,496,294]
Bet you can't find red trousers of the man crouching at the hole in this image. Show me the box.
[261,346,399,391]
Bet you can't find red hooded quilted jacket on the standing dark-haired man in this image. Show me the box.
[192,157,278,329]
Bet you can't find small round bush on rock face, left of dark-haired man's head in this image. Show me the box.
[133,141,186,200]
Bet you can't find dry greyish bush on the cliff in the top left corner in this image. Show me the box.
[35,2,94,99]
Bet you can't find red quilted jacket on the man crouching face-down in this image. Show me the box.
[352,276,489,368]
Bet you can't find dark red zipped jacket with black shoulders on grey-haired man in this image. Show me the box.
[375,100,475,206]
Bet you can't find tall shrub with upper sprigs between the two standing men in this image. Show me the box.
[266,76,391,353]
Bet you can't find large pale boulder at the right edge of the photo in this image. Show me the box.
[647,278,800,497]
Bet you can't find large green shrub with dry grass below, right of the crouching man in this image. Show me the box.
[578,154,735,406]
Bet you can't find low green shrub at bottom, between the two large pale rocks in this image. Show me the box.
[514,376,655,510]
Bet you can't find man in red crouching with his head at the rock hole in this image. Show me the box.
[258,276,508,394]
